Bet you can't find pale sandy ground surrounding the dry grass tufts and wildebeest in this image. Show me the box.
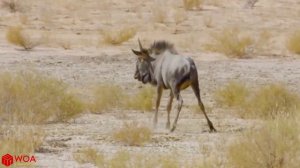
[0,0,300,167]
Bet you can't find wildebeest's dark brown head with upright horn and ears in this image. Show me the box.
[132,40,155,83]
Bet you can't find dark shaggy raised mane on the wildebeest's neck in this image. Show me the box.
[149,41,178,55]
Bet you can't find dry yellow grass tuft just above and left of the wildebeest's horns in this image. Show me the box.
[101,27,137,45]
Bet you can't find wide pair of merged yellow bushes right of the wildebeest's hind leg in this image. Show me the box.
[215,82,300,119]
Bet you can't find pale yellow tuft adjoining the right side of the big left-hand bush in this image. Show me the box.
[90,83,126,113]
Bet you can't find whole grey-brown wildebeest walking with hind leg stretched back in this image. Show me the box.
[132,40,216,132]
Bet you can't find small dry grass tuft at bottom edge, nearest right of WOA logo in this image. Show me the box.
[73,148,105,167]
